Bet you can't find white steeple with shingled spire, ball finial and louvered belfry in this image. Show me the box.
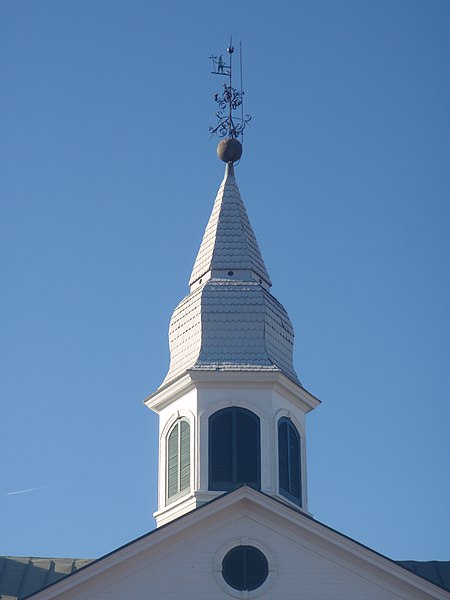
[145,138,319,526]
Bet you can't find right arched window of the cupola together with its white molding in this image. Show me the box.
[274,410,306,508]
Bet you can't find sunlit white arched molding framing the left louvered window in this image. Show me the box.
[159,410,196,506]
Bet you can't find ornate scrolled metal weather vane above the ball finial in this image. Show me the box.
[209,37,251,139]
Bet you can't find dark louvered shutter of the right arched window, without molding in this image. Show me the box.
[278,418,302,506]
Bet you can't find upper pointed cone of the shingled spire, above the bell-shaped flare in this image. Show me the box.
[189,163,272,286]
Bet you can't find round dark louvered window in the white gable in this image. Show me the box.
[222,546,269,592]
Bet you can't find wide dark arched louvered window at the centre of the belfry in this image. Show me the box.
[209,407,261,491]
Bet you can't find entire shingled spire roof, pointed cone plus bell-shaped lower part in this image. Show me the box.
[158,155,300,385]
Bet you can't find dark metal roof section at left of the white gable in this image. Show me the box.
[0,556,91,600]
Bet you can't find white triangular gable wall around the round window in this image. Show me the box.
[28,486,450,600]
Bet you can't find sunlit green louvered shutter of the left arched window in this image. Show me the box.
[167,418,191,502]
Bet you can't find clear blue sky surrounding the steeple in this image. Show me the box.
[0,0,450,560]
